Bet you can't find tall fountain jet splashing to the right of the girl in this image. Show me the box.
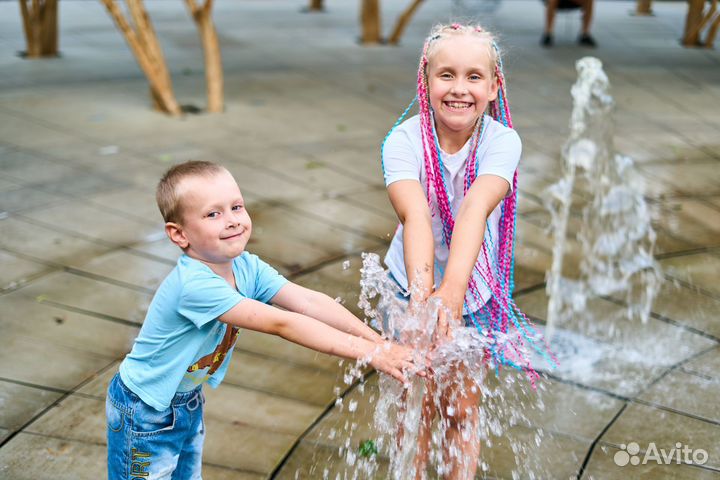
[545,57,661,338]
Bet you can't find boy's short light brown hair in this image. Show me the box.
[155,160,227,223]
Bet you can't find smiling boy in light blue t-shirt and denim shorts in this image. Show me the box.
[106,161,422,480]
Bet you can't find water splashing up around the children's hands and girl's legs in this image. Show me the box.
[320,254,543,480]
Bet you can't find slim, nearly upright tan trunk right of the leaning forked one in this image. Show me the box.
[185,0,224,113]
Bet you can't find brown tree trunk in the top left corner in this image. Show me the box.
[20,0,58,58]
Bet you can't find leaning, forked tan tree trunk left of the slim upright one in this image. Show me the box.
[101,0,181,116]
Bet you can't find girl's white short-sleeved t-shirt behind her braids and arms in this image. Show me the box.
[383,115,522,314]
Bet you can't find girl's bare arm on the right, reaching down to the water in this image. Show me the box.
[433,175,510,337]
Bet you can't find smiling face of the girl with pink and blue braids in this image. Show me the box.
[427,34,498,143]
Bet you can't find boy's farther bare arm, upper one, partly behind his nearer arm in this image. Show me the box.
[272,283,382,342]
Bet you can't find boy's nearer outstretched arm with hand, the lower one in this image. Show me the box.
[220,299,415,383]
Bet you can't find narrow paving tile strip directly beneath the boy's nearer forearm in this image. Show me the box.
[235,330,340,373]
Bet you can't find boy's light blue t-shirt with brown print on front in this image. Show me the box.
[120,252,287,410]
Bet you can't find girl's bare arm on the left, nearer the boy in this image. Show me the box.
[388,180,435,303]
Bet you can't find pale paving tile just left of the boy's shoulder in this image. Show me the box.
[73,247,177,290]
